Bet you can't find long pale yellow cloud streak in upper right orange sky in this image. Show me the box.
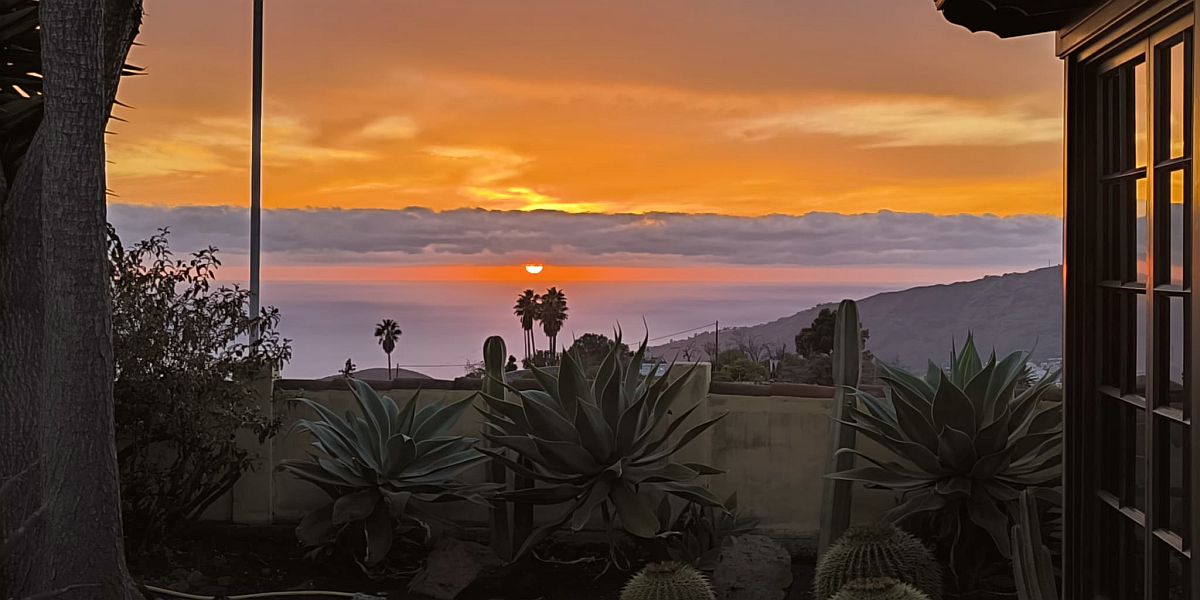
[727,98,1062,148]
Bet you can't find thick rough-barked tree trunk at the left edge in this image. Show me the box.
[0,0,142,599]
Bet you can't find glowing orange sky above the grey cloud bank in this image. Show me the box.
[109,0,1061,216]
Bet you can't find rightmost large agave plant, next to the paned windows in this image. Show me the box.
[829,336,1062,558]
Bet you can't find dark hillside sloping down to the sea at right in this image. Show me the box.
[654,266,1062,368]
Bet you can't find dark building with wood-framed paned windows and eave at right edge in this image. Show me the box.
[935,0,1200,600]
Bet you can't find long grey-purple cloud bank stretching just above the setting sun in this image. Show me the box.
[109,204,1061,268]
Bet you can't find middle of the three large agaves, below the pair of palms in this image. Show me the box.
[480,332,724,556]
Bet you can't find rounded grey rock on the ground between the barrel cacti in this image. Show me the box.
[713,535,792,600]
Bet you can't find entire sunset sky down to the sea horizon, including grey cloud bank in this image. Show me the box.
[100,0,1062,374]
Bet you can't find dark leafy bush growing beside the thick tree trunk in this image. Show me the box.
[108,228,292,550]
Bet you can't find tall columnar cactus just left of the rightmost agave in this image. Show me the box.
[817,300,863,556]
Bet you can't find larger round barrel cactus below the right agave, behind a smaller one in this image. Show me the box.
[814,526,942,600]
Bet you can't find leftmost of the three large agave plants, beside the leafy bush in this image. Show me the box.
[280,379,491,566]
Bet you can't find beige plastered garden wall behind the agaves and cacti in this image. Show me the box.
[208,365,892,538]
